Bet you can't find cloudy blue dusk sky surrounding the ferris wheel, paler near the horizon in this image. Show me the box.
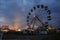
[0,0,60,28]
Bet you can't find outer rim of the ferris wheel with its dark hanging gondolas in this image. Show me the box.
[27,5,51,29]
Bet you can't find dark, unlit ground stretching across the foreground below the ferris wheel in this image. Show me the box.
[2,33,60,40]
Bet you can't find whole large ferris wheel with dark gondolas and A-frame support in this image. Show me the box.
[27,5,51,29]
